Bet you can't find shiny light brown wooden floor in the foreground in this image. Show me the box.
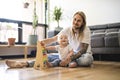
[0,60,120,80]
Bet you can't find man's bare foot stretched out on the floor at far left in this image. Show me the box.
[6,60,27,68]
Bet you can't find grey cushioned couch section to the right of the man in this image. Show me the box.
[89,23,120,54]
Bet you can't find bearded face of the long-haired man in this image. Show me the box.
[72,14,83,32]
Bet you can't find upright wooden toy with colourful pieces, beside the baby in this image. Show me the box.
[34,41,48,69]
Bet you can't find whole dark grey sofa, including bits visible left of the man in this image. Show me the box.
[48,23,120,61]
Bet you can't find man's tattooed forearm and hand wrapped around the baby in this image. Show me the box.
[71,43,89,61]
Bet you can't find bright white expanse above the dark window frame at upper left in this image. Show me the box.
[0,0,44,23]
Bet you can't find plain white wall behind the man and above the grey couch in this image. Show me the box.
[50,0,120,28]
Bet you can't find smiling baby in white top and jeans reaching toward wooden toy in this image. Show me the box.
[46,34,73,67]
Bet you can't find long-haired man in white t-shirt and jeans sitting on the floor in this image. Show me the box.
[6,11,93,68]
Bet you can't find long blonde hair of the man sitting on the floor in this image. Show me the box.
[72,11,86,39]
